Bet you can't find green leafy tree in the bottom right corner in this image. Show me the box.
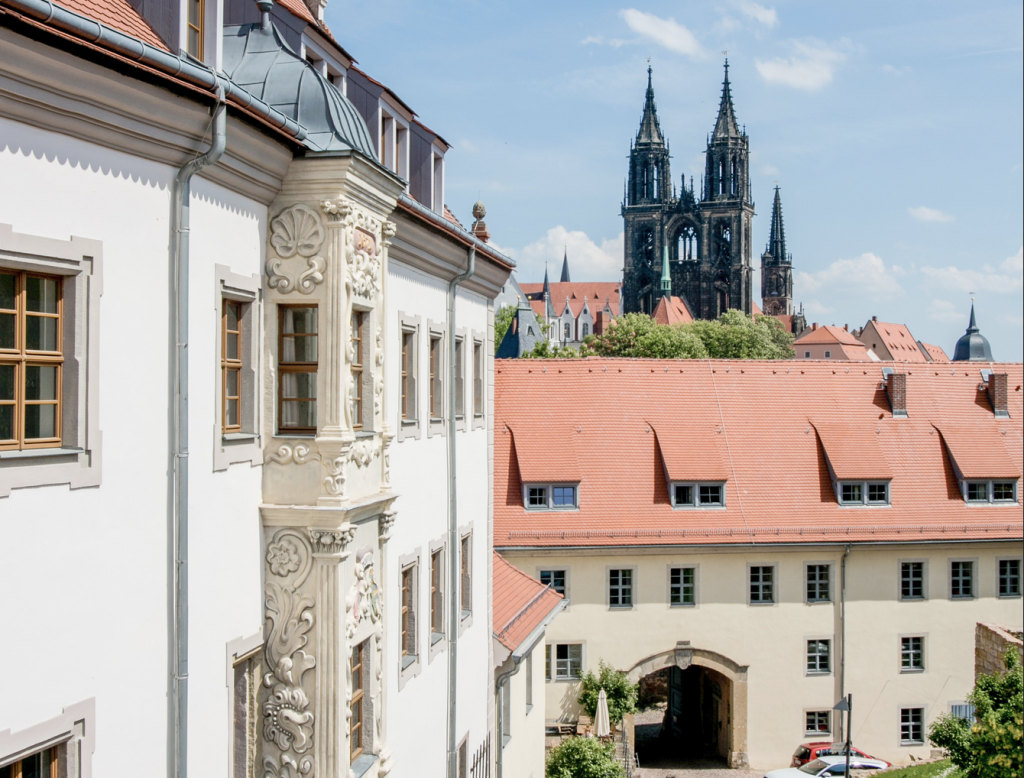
[928,647,1024,778]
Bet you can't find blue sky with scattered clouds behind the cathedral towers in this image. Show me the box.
[327,0,1024,361]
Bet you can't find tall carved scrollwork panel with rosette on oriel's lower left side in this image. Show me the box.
[262,529,316,778]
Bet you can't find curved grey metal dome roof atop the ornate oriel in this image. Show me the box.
[224,24,377,161]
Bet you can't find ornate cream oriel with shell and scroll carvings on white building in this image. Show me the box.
[260,154,402,778]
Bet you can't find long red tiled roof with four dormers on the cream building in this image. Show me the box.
[494,357,1024,549]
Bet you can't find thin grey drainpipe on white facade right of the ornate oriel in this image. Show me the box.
[447,246,476,778]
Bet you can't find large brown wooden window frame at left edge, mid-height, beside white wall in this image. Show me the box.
[0,269,65,450]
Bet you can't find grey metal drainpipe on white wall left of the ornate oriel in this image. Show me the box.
[170,84,227,778]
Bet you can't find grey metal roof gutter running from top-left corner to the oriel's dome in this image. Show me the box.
[0,0,306,140]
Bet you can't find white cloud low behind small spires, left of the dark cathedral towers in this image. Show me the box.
[503,224,625,284]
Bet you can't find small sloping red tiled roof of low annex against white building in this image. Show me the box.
[492,553,562,651]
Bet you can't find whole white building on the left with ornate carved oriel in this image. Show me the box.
[0,0,512,778]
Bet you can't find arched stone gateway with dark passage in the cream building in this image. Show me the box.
[628,642,750,768]
